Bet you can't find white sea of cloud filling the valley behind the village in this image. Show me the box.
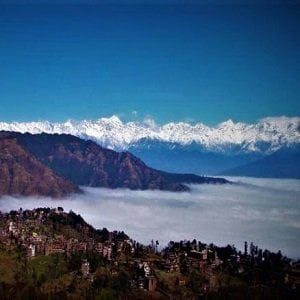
[0,177,300,258]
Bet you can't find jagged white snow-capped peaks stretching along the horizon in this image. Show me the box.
[0,116,300,153]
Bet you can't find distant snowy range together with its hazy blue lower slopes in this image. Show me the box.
[0,116,300,178]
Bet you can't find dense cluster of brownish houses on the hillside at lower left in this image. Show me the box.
[0,208,123,260]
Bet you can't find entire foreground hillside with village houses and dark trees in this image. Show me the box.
[0,207,300,299]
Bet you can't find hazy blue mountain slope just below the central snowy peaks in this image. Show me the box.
[129,140,264,175]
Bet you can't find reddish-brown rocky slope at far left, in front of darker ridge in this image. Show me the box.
[0,135,78,197]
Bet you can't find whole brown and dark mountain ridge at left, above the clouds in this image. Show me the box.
[0,131,227,197]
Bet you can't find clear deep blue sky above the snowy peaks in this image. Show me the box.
[0,0,300,125]
